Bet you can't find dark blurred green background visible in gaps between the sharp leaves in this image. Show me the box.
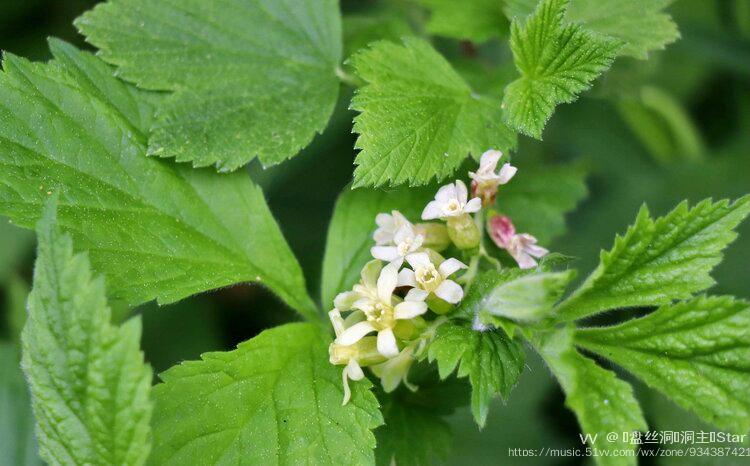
[0,0,750,466]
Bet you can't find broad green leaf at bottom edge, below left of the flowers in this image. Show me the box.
[152,324,382,465]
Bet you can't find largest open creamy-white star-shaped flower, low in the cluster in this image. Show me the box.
[336,261,427,357]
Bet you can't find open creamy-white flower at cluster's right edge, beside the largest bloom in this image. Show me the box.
[398,252,467,304]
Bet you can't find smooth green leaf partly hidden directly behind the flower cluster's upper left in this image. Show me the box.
[321,186,434,309]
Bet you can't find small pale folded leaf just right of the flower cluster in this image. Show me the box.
[458,268,575,323]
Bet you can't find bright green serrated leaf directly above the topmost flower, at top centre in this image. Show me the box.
[351,38,516,187]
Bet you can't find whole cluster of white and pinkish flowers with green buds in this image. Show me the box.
[328,150,547,404]
